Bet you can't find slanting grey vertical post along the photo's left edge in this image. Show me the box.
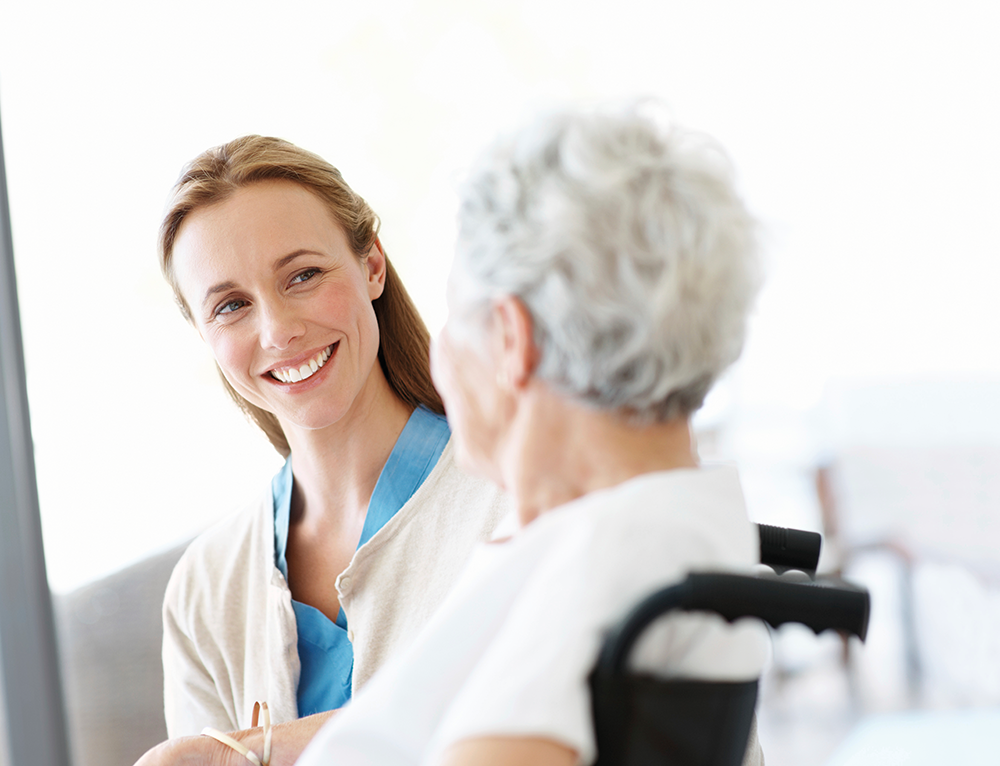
[0,103,70,766]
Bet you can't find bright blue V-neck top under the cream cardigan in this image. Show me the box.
[271,406,451,716]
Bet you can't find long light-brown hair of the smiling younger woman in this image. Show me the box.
[159,136,444,457]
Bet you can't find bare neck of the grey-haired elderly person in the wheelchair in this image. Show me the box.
[501,386,698,524]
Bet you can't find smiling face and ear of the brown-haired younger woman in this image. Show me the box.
[172,181,385,429]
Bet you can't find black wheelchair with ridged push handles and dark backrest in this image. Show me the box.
[589,525,871,766]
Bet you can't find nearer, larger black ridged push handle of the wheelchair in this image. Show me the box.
[597,573,871,673]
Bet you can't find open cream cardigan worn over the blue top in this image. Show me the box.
[163,442,509,737]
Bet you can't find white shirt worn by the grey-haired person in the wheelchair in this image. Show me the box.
[299,468,767,766]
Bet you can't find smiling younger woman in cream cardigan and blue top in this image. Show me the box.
[139,136,506,766]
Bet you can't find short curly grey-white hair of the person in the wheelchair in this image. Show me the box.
[452,104,760,422]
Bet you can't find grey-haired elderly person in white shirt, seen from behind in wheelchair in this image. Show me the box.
[286,102,766,766]
